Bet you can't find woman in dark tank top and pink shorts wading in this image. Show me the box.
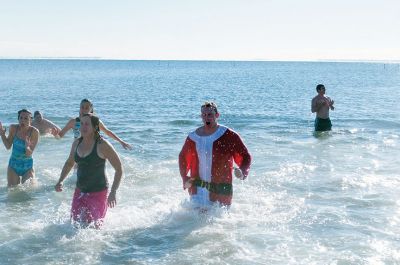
[55,114,123,228]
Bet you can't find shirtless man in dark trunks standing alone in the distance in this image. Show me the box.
[311,84,335,132]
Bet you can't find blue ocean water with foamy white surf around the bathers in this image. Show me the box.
[0,60,400,264]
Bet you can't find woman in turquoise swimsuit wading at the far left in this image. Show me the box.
[0,109,39,187]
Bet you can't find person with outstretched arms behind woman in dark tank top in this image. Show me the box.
[58,98,132,150]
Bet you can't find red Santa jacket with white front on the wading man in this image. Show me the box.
[179,125,251,205]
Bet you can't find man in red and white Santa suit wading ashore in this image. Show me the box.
[179,102,251,206]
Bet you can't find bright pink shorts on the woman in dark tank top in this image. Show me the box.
[71,188,108,224]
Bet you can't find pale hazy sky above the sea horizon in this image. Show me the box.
[0,0,400,61]
